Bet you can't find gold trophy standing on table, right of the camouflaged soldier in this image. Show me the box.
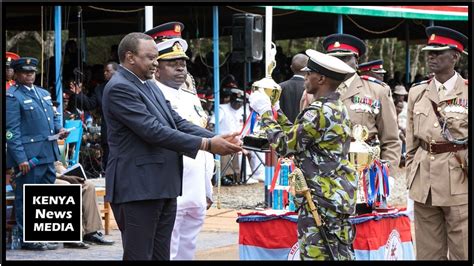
[349,125,380,206]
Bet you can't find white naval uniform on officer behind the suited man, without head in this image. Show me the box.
[155,80,214,260]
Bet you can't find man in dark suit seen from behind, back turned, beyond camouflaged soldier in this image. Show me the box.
[279,54,308,122]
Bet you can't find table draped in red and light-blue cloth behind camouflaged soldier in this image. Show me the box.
[237,210,415,260]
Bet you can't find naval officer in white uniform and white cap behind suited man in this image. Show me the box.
[155,38,214,260]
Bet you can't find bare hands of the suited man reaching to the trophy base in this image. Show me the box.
[200,132,242,155]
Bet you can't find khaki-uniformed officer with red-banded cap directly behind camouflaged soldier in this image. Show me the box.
[302,34,401,170]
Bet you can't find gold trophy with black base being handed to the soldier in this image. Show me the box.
[243,43,281,152]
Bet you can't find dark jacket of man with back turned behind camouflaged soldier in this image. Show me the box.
[279,76,304,122]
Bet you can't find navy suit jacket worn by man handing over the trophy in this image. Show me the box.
[102,66,214,203]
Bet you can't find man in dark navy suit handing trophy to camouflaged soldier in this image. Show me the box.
[102,32,242,260]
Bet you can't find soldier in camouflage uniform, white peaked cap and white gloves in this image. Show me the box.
[249,49,357,260]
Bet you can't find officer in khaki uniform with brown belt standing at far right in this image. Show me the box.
[406,26,469,260]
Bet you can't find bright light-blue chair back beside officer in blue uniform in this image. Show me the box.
[64,120,83,167]
